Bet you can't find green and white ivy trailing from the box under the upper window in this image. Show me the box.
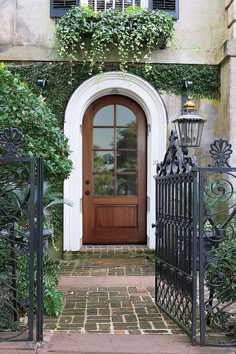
[56,6,174,72]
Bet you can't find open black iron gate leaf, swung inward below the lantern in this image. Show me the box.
[154,133,197,344]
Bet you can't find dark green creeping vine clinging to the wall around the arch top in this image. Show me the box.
[8,62,220,128]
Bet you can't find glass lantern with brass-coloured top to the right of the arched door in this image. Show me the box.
[173,81,206,147]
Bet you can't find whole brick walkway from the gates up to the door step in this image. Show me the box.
[44,250,185,335]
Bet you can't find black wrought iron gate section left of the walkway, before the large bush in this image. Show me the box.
[0,128,43,341]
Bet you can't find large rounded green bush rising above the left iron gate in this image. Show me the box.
[0,64,72,179]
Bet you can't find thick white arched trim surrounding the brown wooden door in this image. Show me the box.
[64,72,167,251]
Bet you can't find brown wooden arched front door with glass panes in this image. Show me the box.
[83,95,146,244]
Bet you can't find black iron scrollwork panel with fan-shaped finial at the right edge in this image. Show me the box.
[203,170,236,345]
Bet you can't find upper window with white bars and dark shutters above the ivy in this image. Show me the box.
[50,0,179,19]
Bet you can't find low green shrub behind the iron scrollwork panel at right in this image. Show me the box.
[206,238,236,303]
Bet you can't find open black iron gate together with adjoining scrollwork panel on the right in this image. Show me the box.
[153,133,236,346]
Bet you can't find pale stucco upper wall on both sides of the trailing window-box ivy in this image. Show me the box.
[0,0,225,64]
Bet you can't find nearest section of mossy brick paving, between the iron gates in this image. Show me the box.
[44,287,184,335]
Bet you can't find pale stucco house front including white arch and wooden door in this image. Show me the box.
[0,0,236,251]
